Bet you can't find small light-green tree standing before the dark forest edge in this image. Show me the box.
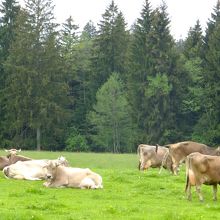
[88,73,132,153]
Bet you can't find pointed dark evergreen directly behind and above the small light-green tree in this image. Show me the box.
[91,1,128,95]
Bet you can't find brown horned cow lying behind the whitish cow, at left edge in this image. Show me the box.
[0,149,31,170]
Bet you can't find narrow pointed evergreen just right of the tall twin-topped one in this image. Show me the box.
[181,21,204,140]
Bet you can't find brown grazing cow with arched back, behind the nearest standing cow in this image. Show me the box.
[162,141,220,175]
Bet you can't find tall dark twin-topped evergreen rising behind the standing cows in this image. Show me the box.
[128,0,182,144]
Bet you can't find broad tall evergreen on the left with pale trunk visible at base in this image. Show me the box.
[5,0,68,150]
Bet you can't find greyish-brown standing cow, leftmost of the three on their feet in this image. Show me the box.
[137,144,172,171]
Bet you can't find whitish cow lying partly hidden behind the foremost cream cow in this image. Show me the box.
[3,157,68,180]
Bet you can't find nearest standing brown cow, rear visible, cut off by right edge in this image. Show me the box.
[185,152,220,201]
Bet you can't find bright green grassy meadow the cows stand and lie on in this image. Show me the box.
[0,151,220,220]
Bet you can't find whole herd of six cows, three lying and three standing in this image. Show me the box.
[0,141,220,201]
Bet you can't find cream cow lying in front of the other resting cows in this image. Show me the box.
[43,161,103,189]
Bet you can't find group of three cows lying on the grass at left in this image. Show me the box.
[0,149,103,189]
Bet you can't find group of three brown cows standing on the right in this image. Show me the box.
[137,141,220,201]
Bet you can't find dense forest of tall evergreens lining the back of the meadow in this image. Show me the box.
[0,0,220,153]
